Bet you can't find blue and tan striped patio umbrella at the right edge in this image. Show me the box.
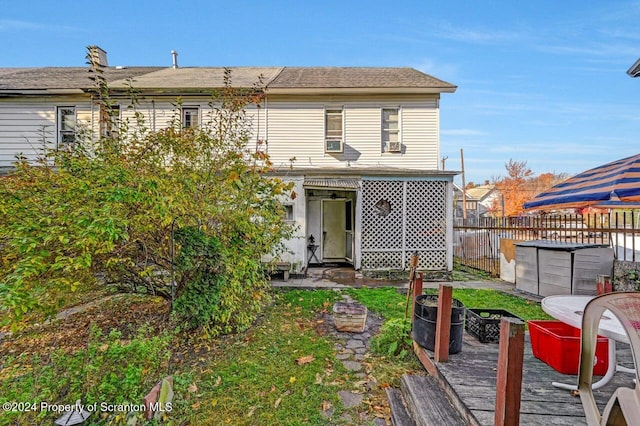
[524,154,640,210]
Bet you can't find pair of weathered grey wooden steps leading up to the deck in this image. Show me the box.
[387,374,467,426]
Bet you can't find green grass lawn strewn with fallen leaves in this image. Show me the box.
[0,288,546,425]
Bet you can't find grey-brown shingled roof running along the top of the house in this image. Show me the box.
[0,67,456,94]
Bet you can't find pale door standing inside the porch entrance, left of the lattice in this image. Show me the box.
[322,200,347,261]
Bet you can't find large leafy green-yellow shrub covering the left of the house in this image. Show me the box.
[0,47,291,333]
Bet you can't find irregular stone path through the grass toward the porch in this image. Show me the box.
[323,295,387,426]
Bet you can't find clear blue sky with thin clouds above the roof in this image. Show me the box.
[0,0,640,183]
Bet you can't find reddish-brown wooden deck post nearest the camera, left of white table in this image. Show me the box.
[494,317,524,426]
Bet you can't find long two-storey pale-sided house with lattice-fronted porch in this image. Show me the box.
[0,46,457,272]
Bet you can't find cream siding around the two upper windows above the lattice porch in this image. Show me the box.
[267,99,439,170]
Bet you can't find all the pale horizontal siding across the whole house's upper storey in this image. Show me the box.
[0,96,439,170]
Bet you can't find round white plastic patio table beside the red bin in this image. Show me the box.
[542,295,635,390]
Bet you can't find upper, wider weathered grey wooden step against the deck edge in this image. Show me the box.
[400,374,467,426]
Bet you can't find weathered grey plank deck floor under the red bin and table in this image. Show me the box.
[425,332,634,426]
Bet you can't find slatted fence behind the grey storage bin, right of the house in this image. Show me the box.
[453,212,640,277]
